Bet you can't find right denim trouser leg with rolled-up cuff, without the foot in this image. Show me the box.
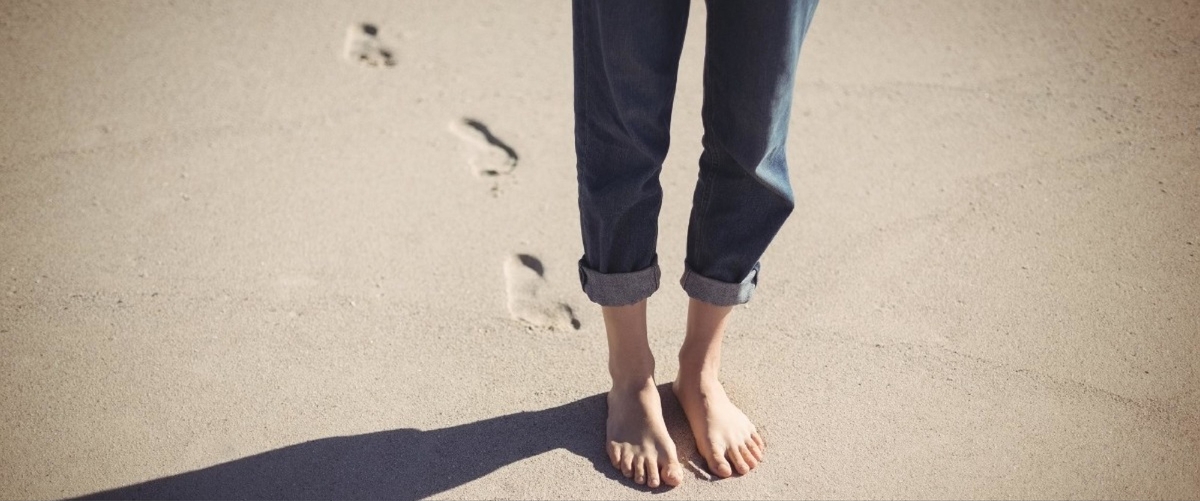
[682,0,816,306]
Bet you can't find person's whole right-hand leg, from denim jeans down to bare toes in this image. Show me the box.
[672,0,816,477]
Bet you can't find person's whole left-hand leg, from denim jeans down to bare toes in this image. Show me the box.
[572,0,688,487]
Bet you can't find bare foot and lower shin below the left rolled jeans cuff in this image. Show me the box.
[604,301,683,488]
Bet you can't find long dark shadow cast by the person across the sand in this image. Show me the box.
[79,385,696,500]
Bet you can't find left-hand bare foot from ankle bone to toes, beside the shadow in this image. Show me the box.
[605,380,683,488]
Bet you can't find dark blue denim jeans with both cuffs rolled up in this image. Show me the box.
[572,0,817,306]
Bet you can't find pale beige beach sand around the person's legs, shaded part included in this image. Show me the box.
[0,0,1200,499]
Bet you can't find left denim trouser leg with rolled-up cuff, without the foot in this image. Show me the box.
[572,0,689,306]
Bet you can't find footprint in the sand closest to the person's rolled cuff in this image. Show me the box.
[504,254,580,331]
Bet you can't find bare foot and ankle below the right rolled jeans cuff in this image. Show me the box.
[671,300,767,478]
